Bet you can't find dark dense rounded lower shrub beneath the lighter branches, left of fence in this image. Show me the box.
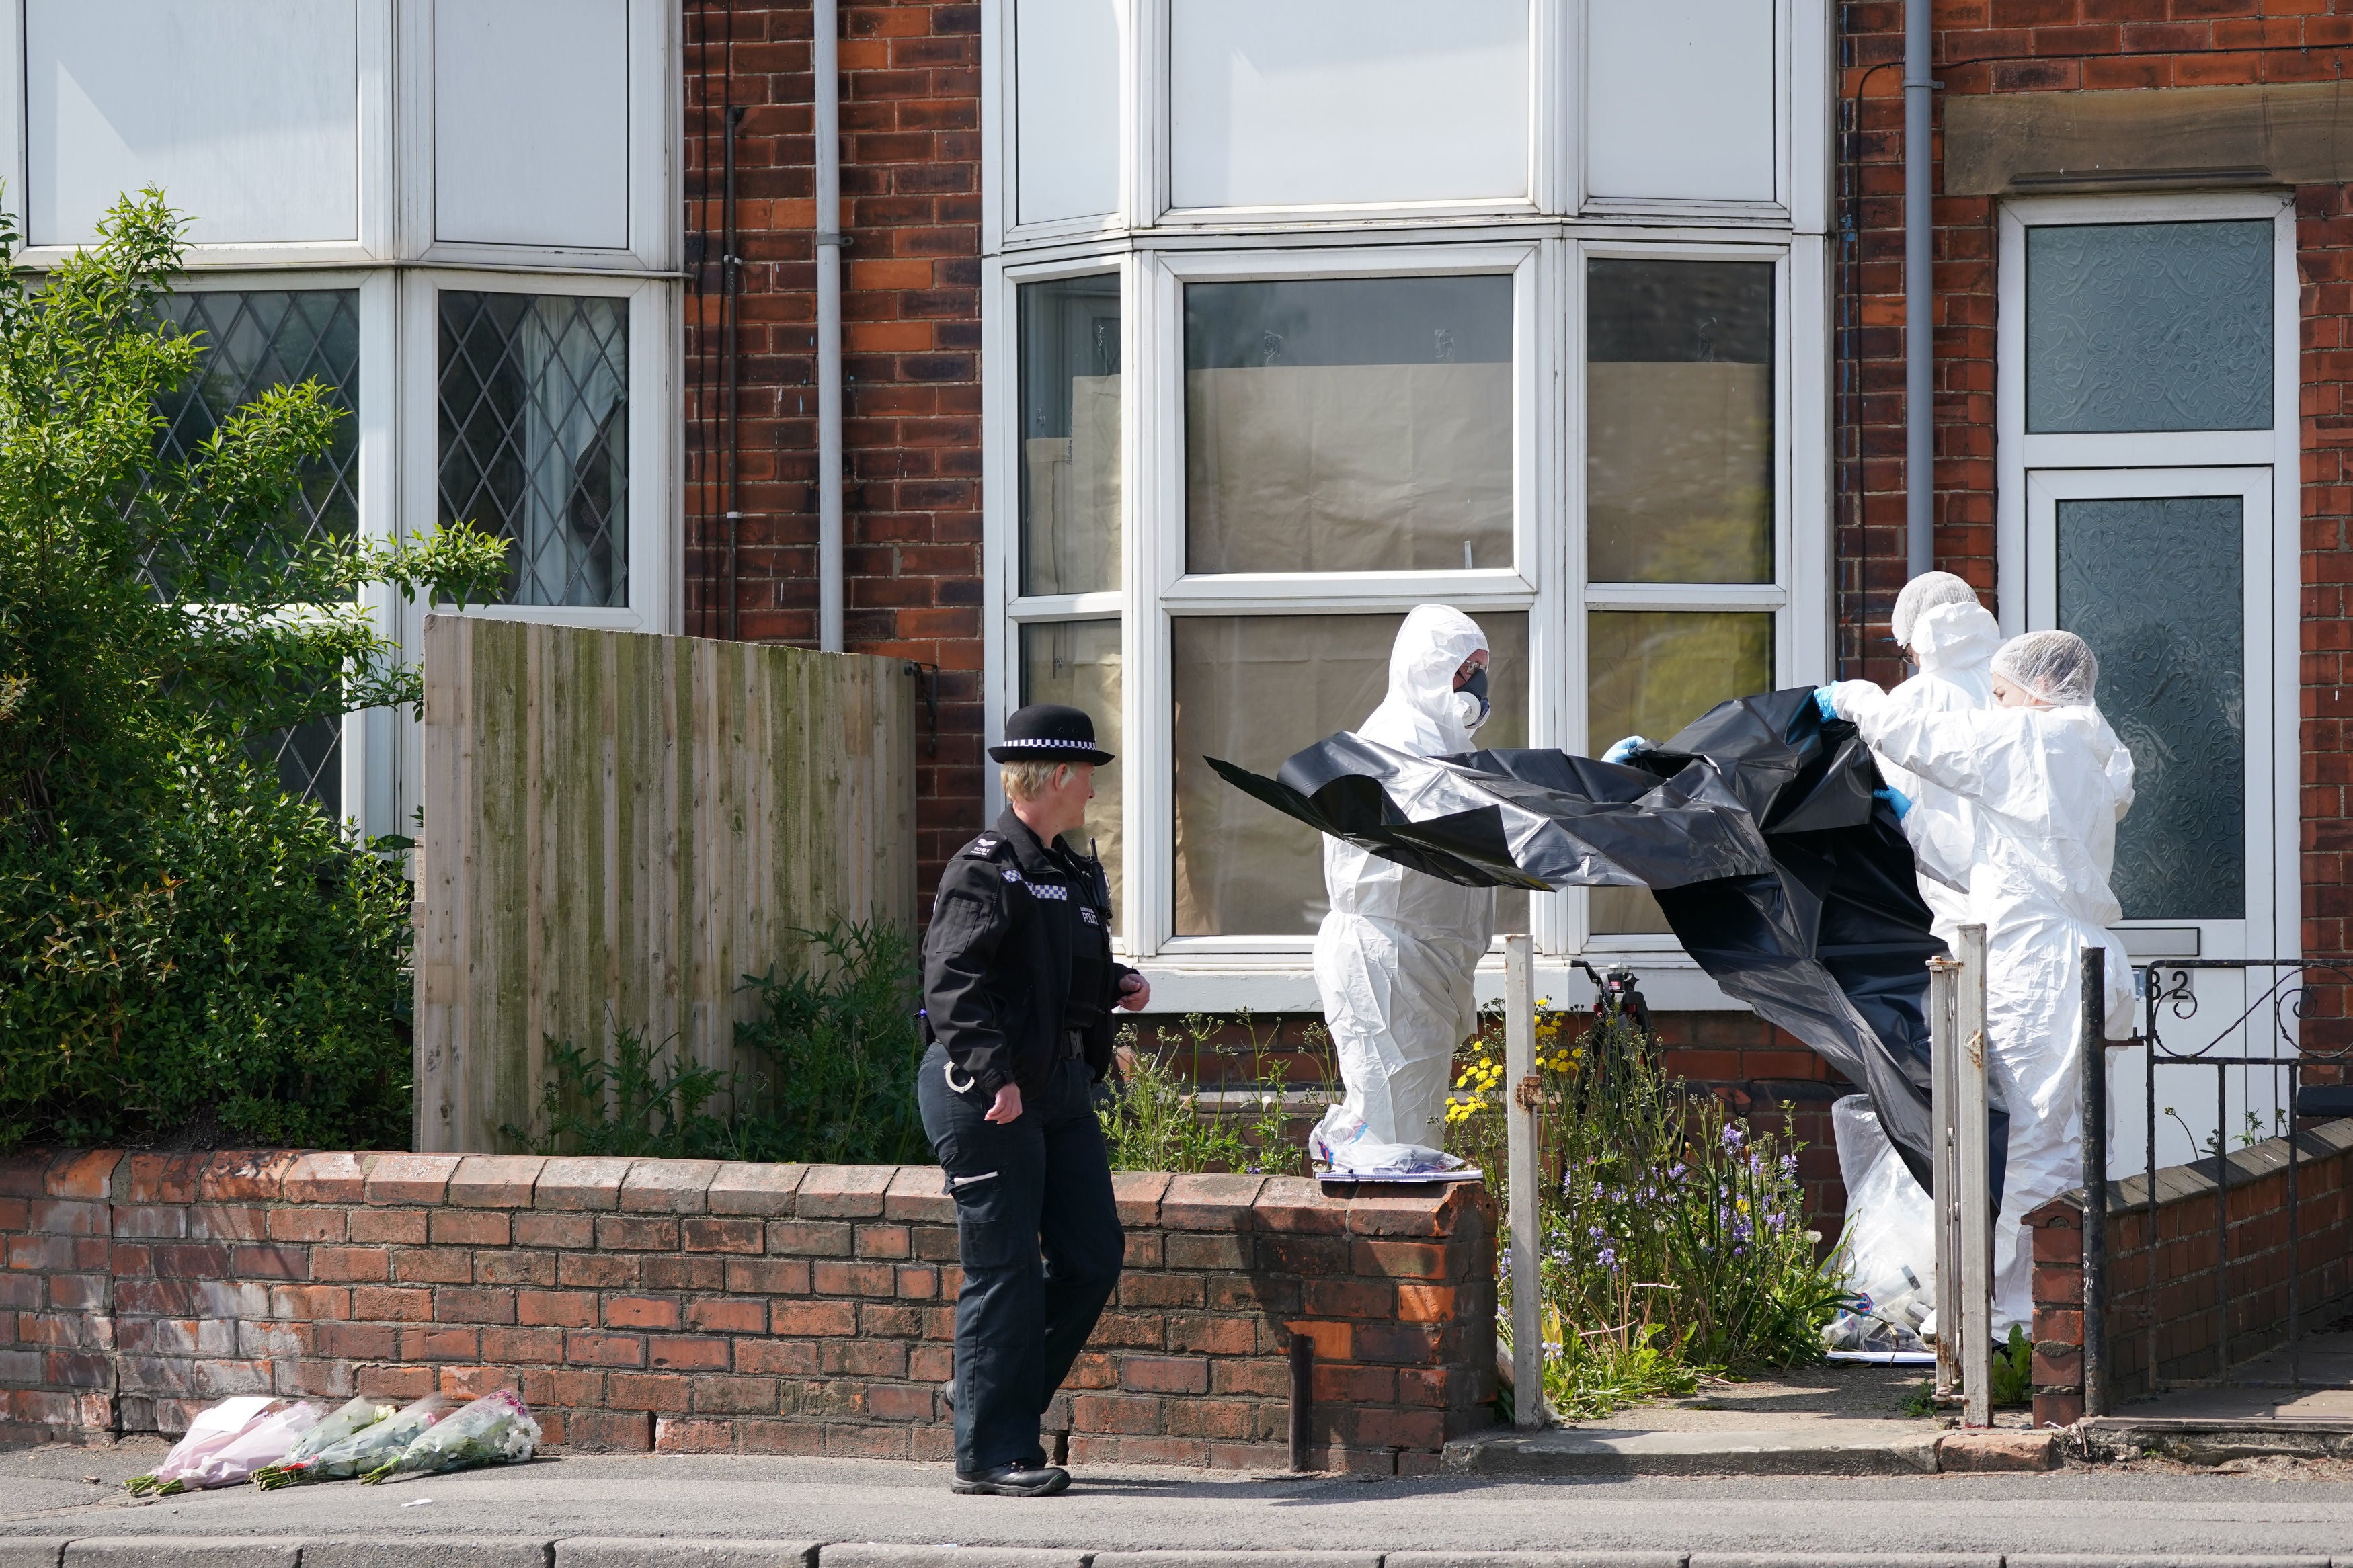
[0,736,409,1149]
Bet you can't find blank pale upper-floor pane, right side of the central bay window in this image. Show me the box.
[1586,0,1779,202]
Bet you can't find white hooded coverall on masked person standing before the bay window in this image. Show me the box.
[1316,604,1494,1149]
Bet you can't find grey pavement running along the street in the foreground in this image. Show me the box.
[13,1444,2353,1568]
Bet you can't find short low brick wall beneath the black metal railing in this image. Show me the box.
[2026,1121,2353,1427]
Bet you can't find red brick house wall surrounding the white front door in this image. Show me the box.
[1838,0,2353,1044]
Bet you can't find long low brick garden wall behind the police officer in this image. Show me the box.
[0,1149,1494,1474]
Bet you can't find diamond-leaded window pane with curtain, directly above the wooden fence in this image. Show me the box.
[440,292,629,606]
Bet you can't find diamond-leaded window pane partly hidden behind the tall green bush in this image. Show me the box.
[153,289,360,816]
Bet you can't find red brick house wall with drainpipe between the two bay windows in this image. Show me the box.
[685,0,984,891]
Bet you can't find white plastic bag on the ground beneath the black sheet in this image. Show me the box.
[1821,1096,1937,1352]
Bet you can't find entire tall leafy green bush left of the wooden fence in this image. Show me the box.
[0,190,504,1147]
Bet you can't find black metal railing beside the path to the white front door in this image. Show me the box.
[2080,948,2353,1415]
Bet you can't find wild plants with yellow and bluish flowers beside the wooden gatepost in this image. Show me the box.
[1449,1011,1843,1417]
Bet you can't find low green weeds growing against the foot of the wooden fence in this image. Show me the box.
[499,921,932,1166]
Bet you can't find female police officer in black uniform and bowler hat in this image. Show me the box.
[916,703,1151,1497]
